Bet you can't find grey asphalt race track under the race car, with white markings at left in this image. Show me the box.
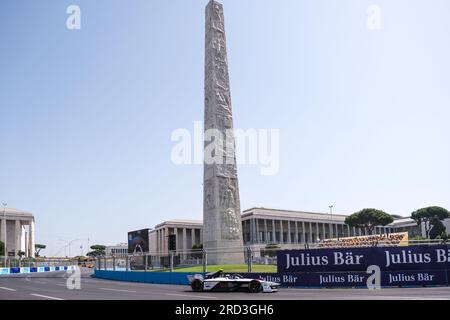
[0,270,450,300]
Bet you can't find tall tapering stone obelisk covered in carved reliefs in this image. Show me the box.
[203,0,244,264]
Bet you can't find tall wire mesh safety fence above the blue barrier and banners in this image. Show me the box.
[95,240,442,273]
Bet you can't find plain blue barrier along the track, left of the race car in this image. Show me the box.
[94,270,199,285]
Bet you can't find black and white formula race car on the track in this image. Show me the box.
[188,270,280,293]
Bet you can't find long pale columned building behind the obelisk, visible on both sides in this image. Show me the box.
[144,208,432,255]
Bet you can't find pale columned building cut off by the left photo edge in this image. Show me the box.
[0,208,35,257]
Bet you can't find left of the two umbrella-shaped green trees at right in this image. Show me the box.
[345,209,394,234]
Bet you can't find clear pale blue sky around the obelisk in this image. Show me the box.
[0,0,450,255]
